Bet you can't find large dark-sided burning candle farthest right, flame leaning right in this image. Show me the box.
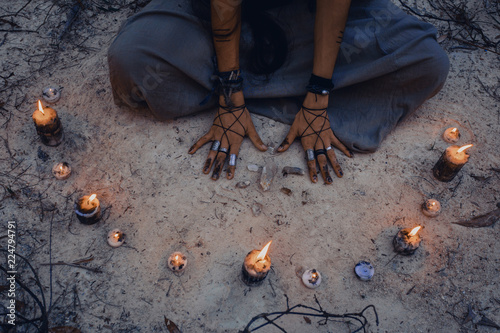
[432,145,472,182]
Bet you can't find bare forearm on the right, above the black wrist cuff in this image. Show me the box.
[313,0,351,78]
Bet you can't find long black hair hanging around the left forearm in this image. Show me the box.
[191,0,292,76]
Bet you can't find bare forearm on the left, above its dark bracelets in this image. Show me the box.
[211,0,241,72]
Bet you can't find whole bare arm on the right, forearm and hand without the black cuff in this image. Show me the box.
[278,0,352,184]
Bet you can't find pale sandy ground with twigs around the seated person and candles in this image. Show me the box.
[0,0,500,332]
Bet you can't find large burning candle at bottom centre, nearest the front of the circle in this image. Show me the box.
[241,241,272,286]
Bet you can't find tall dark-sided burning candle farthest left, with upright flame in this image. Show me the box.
[32,100,63,146]
